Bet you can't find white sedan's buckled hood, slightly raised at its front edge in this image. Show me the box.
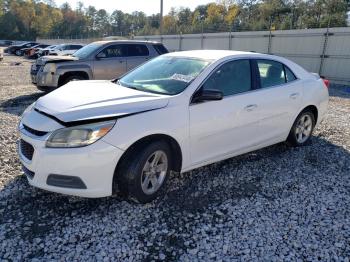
[35,80,169,126]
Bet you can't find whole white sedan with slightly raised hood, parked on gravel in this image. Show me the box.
[19,50,328,203]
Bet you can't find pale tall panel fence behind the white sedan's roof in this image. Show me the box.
[135,27,350,84]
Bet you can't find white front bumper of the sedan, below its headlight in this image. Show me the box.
[18,126,123,198]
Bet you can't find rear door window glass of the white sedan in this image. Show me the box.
[257,60,296,88]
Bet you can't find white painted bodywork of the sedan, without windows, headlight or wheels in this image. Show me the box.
[20,50,328,197]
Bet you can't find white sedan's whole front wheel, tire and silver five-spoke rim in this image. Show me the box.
[116,141,172,203]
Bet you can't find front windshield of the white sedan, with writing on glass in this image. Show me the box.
[118,56,210,95]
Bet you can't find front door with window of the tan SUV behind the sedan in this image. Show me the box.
[93,44,127,80]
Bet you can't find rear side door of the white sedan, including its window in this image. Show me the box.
[255,59,302,143]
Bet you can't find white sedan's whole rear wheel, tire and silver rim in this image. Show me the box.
[287,110,316,146]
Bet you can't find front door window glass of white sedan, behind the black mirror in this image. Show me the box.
[203,59,252,96]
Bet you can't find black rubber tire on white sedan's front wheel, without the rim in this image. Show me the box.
[114,141,173,203]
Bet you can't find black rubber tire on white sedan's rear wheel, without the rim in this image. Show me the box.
[287,110,316,147]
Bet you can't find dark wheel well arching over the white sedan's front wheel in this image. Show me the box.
[112,134,182,194]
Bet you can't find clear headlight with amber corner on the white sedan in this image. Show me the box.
[46,120,116,148]
